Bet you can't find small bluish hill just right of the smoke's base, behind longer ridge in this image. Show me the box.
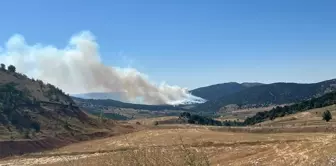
[190,82,262,101]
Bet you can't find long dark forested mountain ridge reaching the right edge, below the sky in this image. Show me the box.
[195,79,336,112]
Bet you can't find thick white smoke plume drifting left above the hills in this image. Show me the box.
[0,31,204,104]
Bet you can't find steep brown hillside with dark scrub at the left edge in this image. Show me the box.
[0,65,135,157]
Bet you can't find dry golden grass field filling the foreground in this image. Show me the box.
[0,126,336,166]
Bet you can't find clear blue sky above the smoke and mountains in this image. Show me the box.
[0,0,336,89]
